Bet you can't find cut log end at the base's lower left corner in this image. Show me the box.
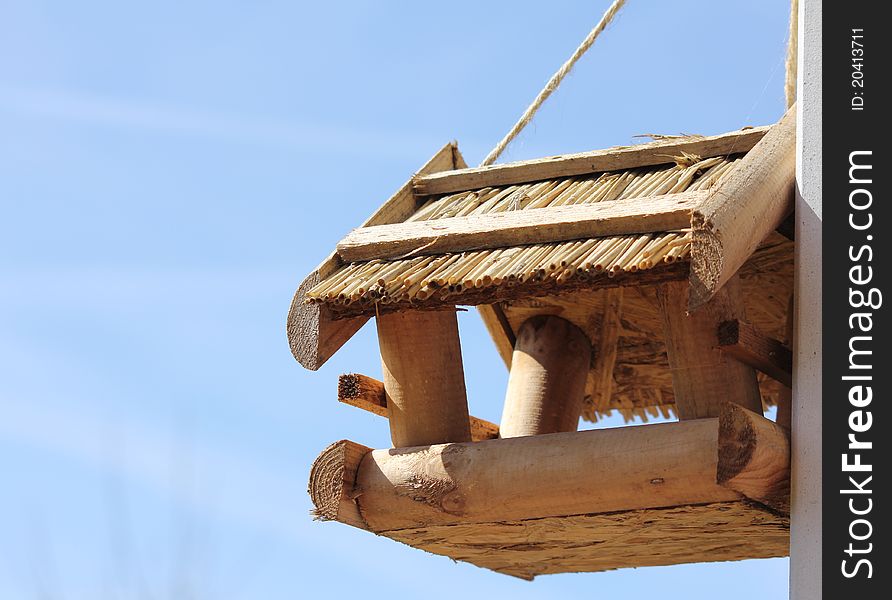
[307,440,372,529]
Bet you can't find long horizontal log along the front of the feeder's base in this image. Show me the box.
[311,404,784,533]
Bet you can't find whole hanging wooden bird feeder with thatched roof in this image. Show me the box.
[288,107,796,578]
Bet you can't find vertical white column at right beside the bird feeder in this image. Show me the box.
[790,0,822,600]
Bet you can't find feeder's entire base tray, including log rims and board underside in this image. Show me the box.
[310,406,789,579]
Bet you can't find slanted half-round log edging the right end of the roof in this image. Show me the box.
[690,104,796,309]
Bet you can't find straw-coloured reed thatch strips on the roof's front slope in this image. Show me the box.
[306,155,739,310]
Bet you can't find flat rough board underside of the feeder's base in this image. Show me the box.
[384,502,790,579]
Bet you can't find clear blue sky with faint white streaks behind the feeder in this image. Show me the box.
[0,0,789,600]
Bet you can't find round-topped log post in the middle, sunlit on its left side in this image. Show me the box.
[499,315,592,438]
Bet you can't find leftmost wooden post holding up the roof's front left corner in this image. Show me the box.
[376,311,471,448]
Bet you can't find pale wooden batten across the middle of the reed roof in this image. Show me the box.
[338,190,708,262]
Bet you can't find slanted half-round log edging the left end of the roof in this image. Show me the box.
[286,142,464,371]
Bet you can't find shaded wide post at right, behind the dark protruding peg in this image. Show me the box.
[657,278,762,420]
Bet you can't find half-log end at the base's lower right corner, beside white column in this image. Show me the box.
[716,403,790,515]
